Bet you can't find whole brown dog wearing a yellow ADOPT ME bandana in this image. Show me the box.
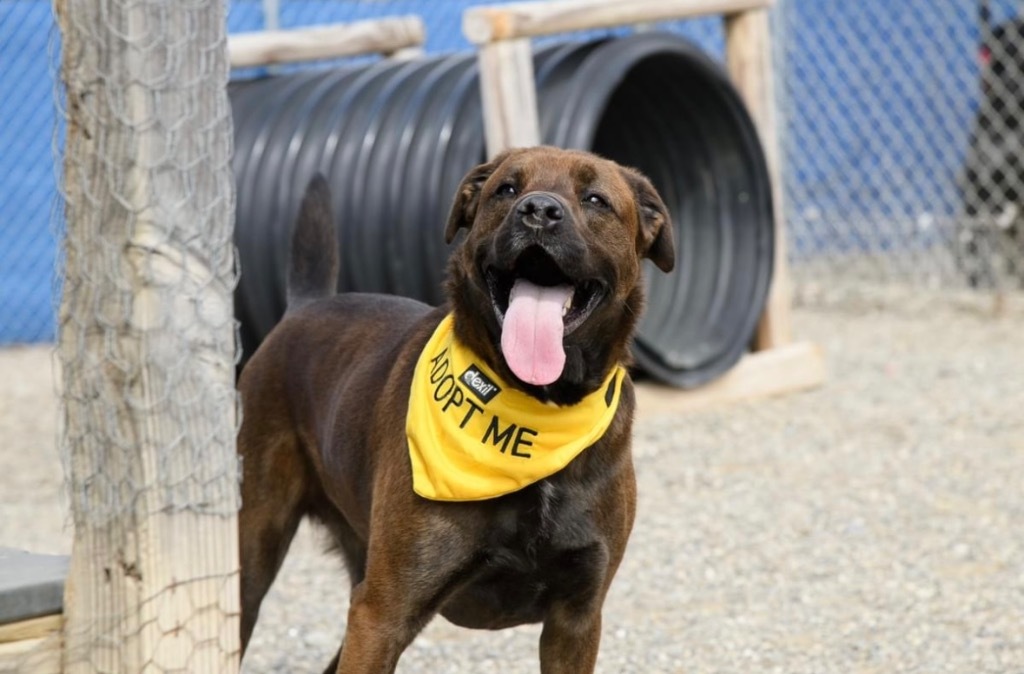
[239,148,674,674]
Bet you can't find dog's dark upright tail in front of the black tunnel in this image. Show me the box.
[288,173,340,311]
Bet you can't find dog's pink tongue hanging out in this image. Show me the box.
[502,279,572,386]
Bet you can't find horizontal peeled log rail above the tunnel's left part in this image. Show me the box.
[227,15,426,68]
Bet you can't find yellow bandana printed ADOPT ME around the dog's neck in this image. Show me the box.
[406,314,626,501]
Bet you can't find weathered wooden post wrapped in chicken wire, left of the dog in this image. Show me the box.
[56,0,239,673]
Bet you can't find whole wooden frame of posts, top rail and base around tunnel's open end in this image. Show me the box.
[463,0,825,399]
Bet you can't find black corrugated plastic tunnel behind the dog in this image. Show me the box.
[230,33,773,387]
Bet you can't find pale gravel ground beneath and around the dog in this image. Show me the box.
[0,295,1024,674]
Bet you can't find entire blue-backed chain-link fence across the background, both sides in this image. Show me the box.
[0,0,1024,343]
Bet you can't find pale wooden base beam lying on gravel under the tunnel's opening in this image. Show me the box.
[637,342,825,417]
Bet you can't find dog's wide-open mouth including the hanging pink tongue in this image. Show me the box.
[484,246,604,386]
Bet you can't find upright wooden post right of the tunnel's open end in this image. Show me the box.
[725,9,793,350]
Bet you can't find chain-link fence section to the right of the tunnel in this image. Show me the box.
[775,0,1024,289]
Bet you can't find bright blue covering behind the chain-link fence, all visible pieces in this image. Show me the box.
[0,0,1015,344]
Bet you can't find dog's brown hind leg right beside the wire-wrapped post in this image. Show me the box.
[239,422,306,652]
